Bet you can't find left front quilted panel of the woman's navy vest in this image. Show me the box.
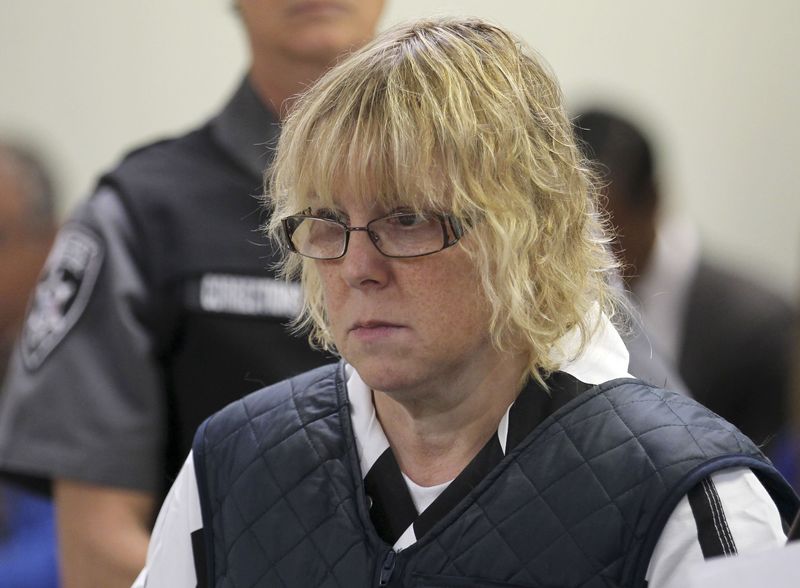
[200,367,376,588]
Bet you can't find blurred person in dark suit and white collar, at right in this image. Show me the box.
[574,109,793,460]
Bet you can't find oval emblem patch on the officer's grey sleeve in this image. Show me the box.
[20,228,103,370]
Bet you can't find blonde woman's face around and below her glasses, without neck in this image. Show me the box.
[313,198,497,394]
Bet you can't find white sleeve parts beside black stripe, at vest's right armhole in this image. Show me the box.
[647,468,786,588]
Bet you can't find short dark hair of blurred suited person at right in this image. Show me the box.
[574,109,656,208]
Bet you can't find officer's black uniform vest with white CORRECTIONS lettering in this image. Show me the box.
[101,126,329,476]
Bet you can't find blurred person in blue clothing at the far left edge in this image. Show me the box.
[0,141,58,588]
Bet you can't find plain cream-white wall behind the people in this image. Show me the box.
[0,0,800,299]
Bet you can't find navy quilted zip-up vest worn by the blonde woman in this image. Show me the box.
[194,365,797,588]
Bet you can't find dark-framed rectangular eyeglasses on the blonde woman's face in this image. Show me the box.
[281,212,464,259]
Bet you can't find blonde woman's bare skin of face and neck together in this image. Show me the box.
[314,200,527,486]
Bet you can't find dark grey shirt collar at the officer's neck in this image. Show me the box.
[211,77,280,177]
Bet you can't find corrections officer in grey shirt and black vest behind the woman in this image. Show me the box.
[0,0,383,588]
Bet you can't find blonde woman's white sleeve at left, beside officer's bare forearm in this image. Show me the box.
[132,453,205,588]
